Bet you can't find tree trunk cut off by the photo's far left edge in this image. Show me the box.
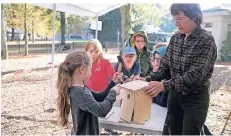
[1,4,8,59]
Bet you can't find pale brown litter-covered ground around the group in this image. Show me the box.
[1,55,231,135]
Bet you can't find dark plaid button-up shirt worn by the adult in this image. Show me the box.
[146,26,217,94]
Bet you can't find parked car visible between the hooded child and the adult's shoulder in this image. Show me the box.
[147,32,172,51]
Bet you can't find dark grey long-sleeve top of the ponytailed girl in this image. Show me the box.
[69,81,116,135]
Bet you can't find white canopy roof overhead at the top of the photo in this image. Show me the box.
[32,3,125,17]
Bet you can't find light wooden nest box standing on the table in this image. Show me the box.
[120,80,152,124]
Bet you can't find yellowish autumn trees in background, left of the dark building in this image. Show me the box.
[1,3,85,58]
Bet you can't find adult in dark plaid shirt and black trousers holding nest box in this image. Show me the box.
[144,4,217,135]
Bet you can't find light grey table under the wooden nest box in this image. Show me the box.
[99,103,167,135]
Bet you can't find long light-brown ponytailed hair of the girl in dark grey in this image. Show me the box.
[56,50,91,126]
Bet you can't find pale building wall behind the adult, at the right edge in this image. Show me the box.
[202,13,231,60]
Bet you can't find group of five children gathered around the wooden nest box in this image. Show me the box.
[57,31,168,135]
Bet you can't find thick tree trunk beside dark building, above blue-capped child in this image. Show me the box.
[120,4,132,47]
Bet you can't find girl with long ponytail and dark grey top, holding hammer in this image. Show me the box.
[57,51,122,135]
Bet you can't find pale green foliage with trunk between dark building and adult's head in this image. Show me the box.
[120,4,161,46]
